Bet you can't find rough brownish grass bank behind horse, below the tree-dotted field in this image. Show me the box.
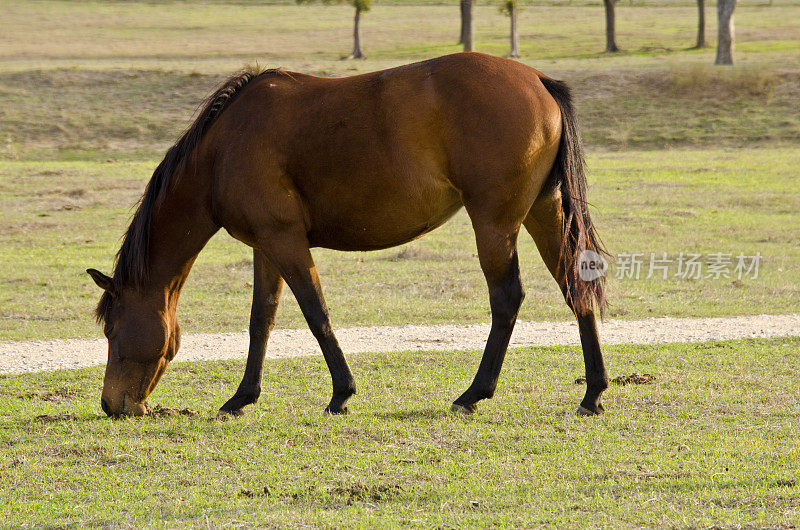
[0,64,800,161]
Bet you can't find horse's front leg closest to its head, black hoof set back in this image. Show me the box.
[220,249,283,416]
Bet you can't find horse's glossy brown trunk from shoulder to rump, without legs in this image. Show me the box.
[203,53,561,250]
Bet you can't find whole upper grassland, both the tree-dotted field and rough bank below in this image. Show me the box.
[0,2,800,160]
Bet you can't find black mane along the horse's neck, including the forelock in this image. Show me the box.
[95,66,268,323]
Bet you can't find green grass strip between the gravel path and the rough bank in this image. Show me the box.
[0,149,800,340]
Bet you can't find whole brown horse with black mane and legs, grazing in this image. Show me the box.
[87,53,608,416]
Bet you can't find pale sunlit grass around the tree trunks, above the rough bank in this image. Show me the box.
[0,0,800,73]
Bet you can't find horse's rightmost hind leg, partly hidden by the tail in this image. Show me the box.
[523,189,608,415]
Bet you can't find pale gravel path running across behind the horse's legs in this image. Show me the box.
[0,314,800,373]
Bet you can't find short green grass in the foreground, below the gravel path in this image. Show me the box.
[0,339,800,528]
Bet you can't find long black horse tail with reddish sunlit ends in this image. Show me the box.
[540,76,608,317]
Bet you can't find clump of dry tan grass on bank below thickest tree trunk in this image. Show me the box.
[670,63,779,99]
